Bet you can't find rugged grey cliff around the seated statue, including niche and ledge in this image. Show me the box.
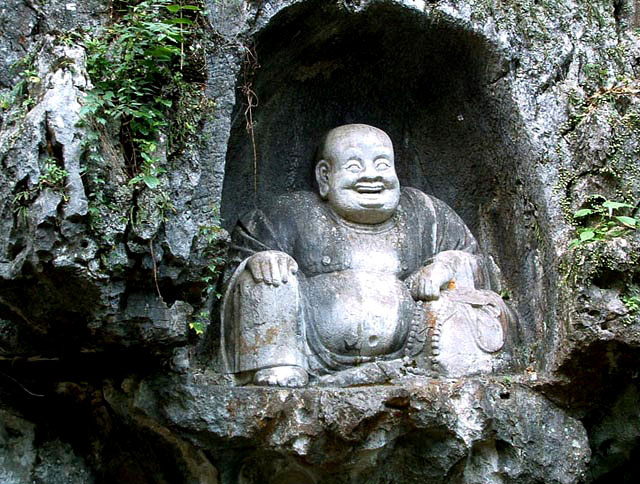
[0,0,640,483]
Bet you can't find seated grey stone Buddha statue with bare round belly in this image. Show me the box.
[221,124,515,387]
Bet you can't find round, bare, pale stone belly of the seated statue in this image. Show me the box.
[305,270,414,356]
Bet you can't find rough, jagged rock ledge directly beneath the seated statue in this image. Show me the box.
[105,374,590,484]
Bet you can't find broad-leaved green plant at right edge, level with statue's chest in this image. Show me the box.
[569,195,640,248]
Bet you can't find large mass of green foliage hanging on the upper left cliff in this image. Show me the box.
[81,0,202,189]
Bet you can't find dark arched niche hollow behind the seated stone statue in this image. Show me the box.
[222,2,540,356]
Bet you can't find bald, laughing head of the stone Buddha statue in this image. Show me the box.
[316,124,400,224]
